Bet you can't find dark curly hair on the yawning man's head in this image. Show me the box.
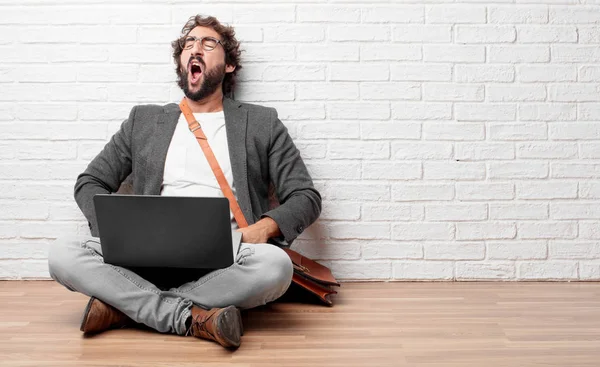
[171,14,242,96]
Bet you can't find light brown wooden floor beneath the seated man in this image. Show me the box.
[0,281,600,367]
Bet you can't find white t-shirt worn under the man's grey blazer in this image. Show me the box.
[160,111,238,230]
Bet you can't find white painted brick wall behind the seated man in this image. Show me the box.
[0,0,600,280]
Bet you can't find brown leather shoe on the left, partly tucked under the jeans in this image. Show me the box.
[80,297,135,334]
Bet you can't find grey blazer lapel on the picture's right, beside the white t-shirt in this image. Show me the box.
[223,98,254,224]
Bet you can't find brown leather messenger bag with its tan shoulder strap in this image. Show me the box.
[179,97,340,306]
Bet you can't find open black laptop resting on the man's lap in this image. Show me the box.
[93,194,242,269]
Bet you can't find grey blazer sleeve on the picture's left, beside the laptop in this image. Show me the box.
[75,106,137,237]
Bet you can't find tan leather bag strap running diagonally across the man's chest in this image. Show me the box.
[179,97,248,228]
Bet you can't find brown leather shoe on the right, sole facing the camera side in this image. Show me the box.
[186,306,244,348]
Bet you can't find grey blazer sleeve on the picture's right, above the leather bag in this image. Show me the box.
[261,109,321,244]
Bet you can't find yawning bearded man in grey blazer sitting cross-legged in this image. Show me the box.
[48,16,321,348]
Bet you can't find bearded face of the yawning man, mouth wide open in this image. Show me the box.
[178,27,235,101]
